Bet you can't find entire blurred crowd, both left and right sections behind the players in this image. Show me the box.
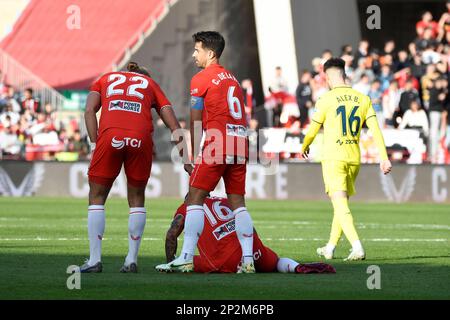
[0,8,450,163]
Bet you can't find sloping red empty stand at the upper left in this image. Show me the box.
[0,0,177,89]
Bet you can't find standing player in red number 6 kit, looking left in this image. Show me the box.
[165,31,255,273]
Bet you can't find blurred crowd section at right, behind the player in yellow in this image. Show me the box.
[256,8,450,163]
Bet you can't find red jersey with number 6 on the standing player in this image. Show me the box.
[191,64,248,157]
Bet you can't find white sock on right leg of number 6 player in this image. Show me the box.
[234,207,253,263]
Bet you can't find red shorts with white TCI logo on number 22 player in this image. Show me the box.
[88,128,153,188]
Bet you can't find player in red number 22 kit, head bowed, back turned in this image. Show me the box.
[80,62,180,273]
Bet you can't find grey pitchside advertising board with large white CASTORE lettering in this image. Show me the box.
[0,161,450,203]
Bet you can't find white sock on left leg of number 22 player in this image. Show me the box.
[88,205,105,266]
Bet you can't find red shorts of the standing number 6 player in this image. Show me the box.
[189,162,247,195]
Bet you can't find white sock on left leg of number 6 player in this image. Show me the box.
[181,205,205,261]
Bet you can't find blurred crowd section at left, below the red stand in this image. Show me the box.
[0,81,89,161]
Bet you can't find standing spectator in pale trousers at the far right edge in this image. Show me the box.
[428,77,448,163]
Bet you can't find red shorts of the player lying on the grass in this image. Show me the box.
[194,234,279,273]
